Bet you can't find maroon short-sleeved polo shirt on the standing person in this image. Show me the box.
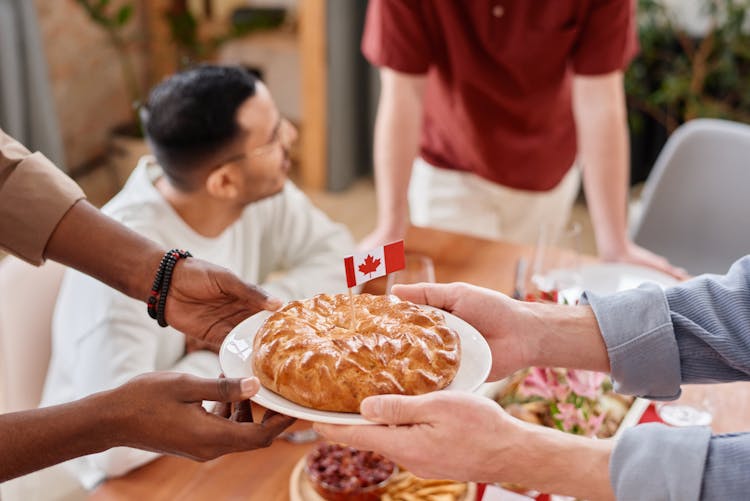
[362,0,637,191]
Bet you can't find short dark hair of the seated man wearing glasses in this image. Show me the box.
[141,65,257,191]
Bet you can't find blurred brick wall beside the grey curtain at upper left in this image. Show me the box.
[34,0,144,169]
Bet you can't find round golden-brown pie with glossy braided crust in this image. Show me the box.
[252,294,461,412]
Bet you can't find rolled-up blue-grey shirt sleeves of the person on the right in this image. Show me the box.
[586,257,750,500]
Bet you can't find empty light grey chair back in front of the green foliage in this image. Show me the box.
[633,119,750,275]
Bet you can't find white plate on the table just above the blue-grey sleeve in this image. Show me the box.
[581,263,677,294]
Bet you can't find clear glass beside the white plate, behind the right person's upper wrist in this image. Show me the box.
[526,222,583,304]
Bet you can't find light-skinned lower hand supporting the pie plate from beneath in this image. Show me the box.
[314,391,523,482]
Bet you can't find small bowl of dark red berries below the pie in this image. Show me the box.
[305,442,398,501]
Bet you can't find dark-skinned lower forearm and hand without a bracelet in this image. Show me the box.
[0,372,294,482]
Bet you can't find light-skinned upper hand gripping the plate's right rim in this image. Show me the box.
[391,283,533,381]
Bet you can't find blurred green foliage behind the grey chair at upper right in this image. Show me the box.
[625,0,750,180]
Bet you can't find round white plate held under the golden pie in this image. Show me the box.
[219,306,492,424]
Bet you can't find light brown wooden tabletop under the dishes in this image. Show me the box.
[89,228,750,501]
